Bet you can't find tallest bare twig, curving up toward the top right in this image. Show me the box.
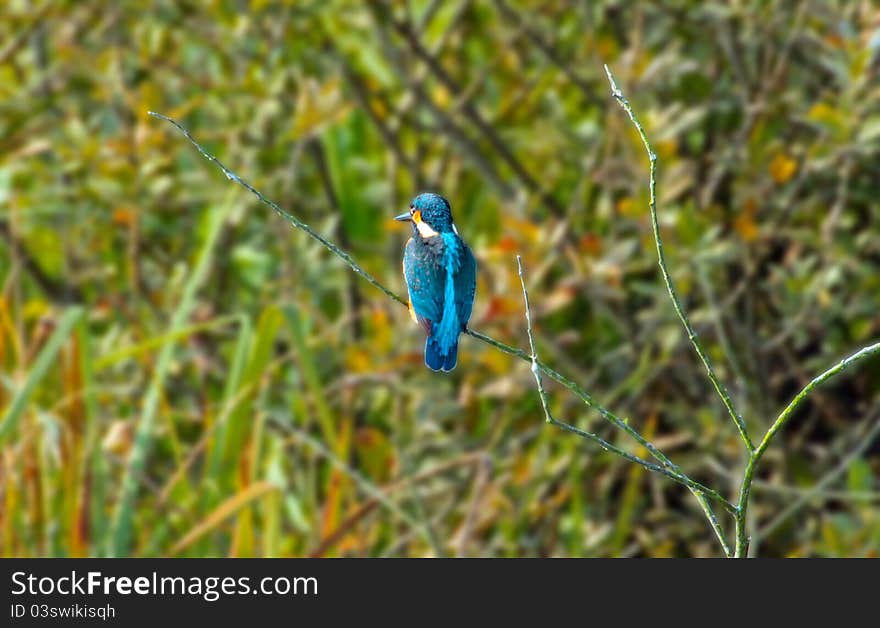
[605,65,755,453]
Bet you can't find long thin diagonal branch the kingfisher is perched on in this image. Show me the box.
[148,111,737,515]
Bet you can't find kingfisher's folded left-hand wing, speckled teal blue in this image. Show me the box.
[403,238,446,333]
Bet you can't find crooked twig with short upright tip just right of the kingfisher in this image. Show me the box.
[516,255,732,544]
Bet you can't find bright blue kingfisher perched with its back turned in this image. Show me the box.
[394,192,477,372]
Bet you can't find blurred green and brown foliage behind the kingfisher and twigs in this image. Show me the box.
[0,0,880,556]
